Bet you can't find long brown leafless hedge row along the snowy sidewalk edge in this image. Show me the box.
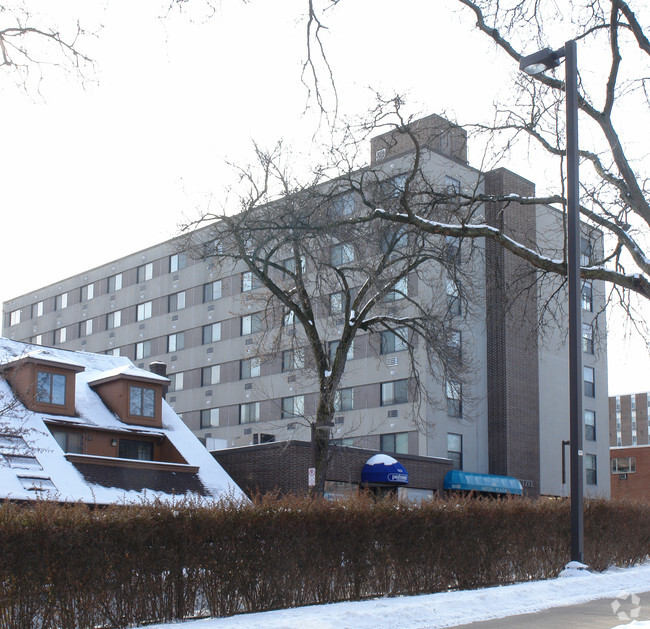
[0,496,650,629]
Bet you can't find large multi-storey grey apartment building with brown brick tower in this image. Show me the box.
[3,115,610,496]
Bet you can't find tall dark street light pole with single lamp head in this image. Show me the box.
[519,40,584,562]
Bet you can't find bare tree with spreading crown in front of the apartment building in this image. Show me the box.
[183,139,475,493]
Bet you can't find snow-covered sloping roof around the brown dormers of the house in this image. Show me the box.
[0,338,244,504]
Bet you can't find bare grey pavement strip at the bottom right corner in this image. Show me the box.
[454,592,650,629]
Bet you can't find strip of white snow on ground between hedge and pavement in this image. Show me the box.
[144,562,650,629]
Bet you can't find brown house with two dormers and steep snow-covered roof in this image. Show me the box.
[0,339,243,505]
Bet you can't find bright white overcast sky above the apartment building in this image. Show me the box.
[0,0,650,393]
